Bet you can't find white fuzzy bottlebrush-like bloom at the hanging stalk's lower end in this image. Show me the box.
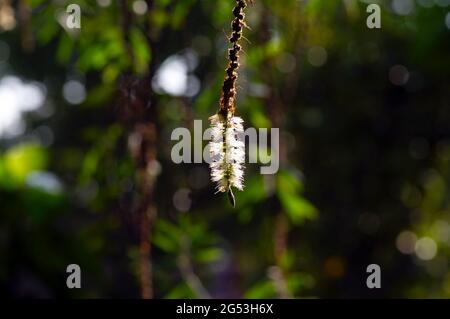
[209,114,245,192]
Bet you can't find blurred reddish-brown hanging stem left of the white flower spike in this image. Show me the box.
[121,0,160,299]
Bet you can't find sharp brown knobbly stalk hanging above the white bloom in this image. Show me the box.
[219,0,247,118]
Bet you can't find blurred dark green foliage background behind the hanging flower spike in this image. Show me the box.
[0,0,450,298]
